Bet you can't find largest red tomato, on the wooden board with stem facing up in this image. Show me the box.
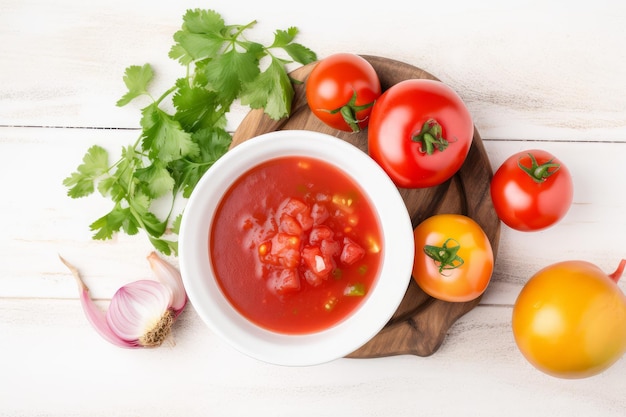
[368,79,474,188]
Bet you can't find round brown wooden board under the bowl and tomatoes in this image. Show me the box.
[231,56,500,358]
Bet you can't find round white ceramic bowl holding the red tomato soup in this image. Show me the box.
[179,130,414,366]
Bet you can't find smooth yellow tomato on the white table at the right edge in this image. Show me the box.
[512,261,626,378]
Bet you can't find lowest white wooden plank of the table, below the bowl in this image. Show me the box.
[0,299,626,417]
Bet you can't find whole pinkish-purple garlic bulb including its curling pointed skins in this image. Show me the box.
[59,252,187,348]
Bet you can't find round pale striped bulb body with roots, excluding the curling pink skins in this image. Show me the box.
[106,280,173,346]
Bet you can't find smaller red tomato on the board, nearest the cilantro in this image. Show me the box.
[306,53,381,132]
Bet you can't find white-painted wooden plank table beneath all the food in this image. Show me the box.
[0,0,626,417]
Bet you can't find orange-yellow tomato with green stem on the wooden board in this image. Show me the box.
[413,214,494,302]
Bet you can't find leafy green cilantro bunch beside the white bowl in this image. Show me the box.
[63,9,317,255]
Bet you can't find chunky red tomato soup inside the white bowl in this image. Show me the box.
[209,156,383,334]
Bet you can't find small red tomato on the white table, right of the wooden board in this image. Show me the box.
[491,149,574,231]
